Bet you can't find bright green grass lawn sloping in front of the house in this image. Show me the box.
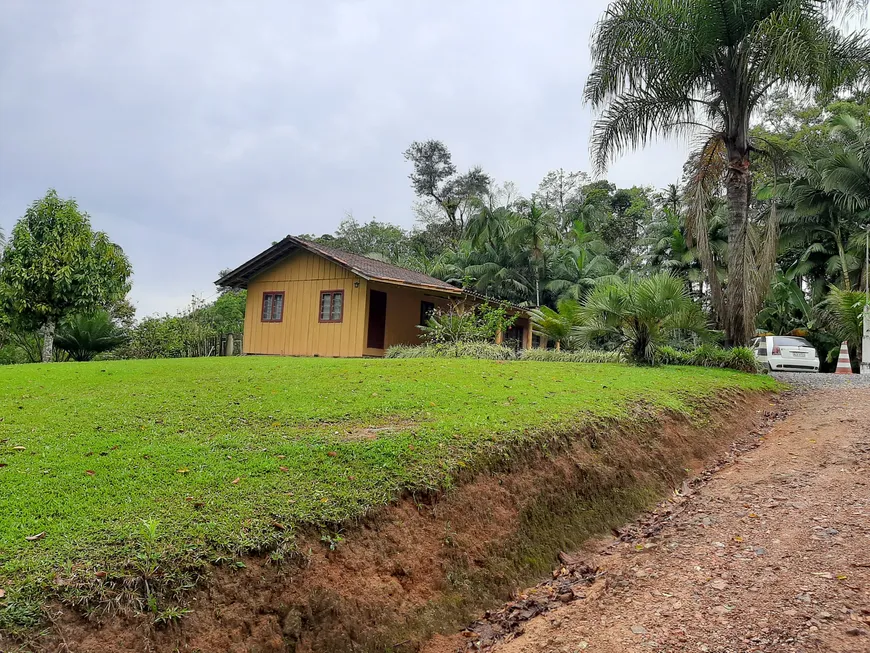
[0,357,776,628]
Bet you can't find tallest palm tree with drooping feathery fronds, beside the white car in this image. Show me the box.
[585,0,870,344]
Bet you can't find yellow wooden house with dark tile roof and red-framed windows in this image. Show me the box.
[216,236,532,357]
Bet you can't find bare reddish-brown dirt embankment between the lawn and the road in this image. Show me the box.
[11,395,773,653]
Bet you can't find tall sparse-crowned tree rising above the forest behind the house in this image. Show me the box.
[405,140,492,241]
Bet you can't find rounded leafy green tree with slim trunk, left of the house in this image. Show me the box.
[0,189,131,362]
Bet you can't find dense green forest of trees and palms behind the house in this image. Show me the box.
[298,100,870,370]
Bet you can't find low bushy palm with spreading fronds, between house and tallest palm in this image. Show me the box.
[574,272,707,364]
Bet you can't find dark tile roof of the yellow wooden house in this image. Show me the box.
[215,236,462,294]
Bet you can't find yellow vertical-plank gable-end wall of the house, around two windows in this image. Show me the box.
[244,251,370,356]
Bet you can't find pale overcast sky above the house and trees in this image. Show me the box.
[0,0,728,317]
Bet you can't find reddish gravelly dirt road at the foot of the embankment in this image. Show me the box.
[427,388,870,653]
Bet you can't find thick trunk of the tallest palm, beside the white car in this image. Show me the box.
[723,153,755,346]
